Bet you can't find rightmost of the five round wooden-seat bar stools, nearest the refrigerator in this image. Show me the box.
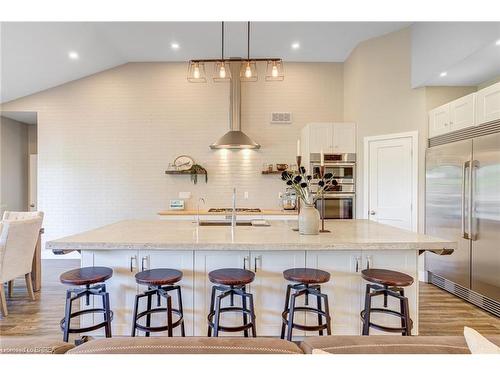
[360,268,413,336]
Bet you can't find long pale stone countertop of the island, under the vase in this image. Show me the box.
[46,220,457,252]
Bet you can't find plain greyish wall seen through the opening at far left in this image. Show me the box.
[0,116,29,214]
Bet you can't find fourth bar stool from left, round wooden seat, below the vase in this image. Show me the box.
[281,268,332,341]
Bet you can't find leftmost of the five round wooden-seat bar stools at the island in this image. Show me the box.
[59,267,113,342]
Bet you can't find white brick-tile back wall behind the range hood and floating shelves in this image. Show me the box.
[2,63,344,255]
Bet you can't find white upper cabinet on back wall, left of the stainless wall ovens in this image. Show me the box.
[302,122,356,156]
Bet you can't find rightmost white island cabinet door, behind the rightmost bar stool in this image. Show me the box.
[360,250,418,335]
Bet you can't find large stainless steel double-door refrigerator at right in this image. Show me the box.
[425,124,500,316]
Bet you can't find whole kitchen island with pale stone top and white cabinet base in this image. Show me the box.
[46,220,456,336]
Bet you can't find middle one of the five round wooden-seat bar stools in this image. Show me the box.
[207,268,257,337]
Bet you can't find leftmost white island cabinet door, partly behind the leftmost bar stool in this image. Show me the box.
[93,250,138,336]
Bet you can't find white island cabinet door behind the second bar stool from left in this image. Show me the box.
[138,250,194,336]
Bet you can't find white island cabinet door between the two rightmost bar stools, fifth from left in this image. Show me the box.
[306,251,362,335]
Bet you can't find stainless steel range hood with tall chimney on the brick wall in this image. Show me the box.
[210,61,260,149]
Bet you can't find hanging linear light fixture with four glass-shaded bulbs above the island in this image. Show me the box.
[187,22,285,83]
